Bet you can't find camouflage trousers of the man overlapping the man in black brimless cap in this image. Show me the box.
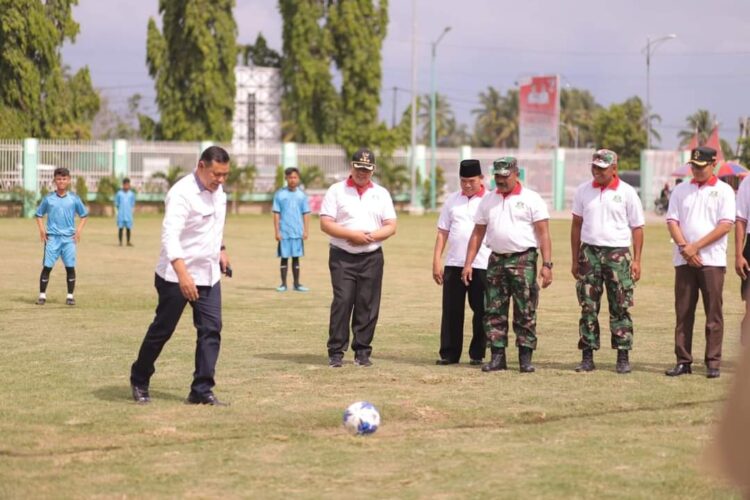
[484,248,539,349]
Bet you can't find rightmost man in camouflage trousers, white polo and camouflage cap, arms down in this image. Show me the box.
[570,149,644,374]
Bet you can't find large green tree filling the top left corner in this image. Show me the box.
[0,0,99,139]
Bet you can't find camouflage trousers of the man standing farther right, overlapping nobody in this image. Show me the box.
[576,243,635,350]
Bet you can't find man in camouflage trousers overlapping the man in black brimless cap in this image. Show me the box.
[461,156,552,373]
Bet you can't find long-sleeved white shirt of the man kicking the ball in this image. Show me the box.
[156,172,227,286]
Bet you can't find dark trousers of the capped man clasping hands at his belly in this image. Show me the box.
[328,246,384,357]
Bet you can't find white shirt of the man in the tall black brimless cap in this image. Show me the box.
[438,186,491,269]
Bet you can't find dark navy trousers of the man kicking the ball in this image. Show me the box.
[130,275,221,395]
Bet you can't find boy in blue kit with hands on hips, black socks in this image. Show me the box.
[36,168,89,306]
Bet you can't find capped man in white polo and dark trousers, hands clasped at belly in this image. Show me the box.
[320,148,396,368]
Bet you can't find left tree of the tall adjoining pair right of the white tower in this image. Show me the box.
[279,0,338,144]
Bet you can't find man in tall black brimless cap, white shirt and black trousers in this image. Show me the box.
[432,160,490,365]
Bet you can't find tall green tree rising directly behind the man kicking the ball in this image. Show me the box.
[146,0,237,142]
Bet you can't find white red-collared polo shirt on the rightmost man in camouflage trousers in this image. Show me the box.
[573,176,645,247]
